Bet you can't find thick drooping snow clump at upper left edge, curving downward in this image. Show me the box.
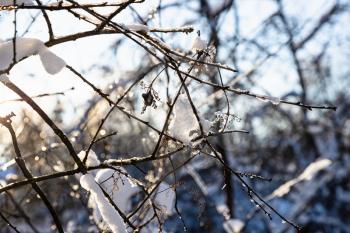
[0,38,66,74]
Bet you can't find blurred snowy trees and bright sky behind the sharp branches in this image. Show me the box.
[0,0,350,233]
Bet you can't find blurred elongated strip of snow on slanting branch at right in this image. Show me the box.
[272,159,332,197]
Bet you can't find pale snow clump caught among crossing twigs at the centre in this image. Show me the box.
[169,94,212,144]
